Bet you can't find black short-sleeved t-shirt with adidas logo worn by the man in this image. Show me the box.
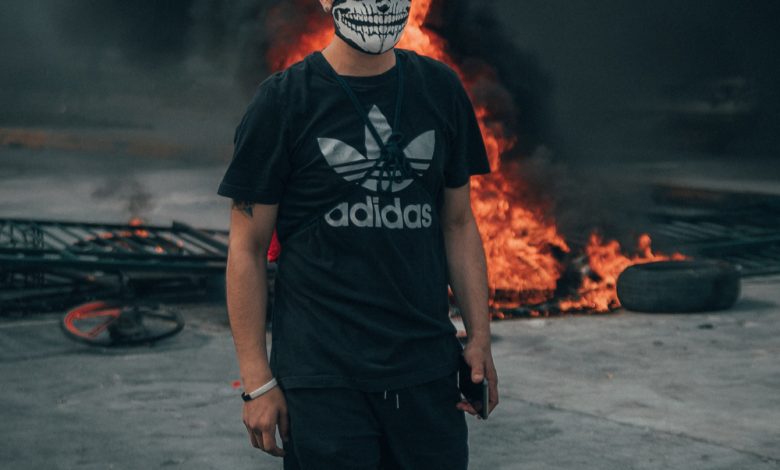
[218,50,490,391]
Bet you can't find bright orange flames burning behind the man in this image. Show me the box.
[267,0,683,316]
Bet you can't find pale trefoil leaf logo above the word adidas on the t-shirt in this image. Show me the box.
[317,105,436,193]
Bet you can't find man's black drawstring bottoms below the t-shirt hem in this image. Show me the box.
[284,373,468,470]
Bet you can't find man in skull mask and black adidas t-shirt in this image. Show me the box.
[218,0,498,470]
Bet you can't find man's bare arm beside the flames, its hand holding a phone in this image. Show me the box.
[442,184,498,414]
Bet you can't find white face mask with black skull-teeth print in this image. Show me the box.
[332,0,412,54]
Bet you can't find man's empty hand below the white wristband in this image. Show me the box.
[243,386,290,457]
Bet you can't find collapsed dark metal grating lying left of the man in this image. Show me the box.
[0,219,228,314]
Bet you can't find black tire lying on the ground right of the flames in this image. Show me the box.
[617,261,740,313]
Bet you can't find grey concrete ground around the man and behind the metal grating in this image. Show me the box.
[0,148,780,470]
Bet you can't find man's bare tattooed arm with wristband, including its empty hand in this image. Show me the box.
[226,201,289,457]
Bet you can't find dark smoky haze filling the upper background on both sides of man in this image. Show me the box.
[0,0,780,158]
